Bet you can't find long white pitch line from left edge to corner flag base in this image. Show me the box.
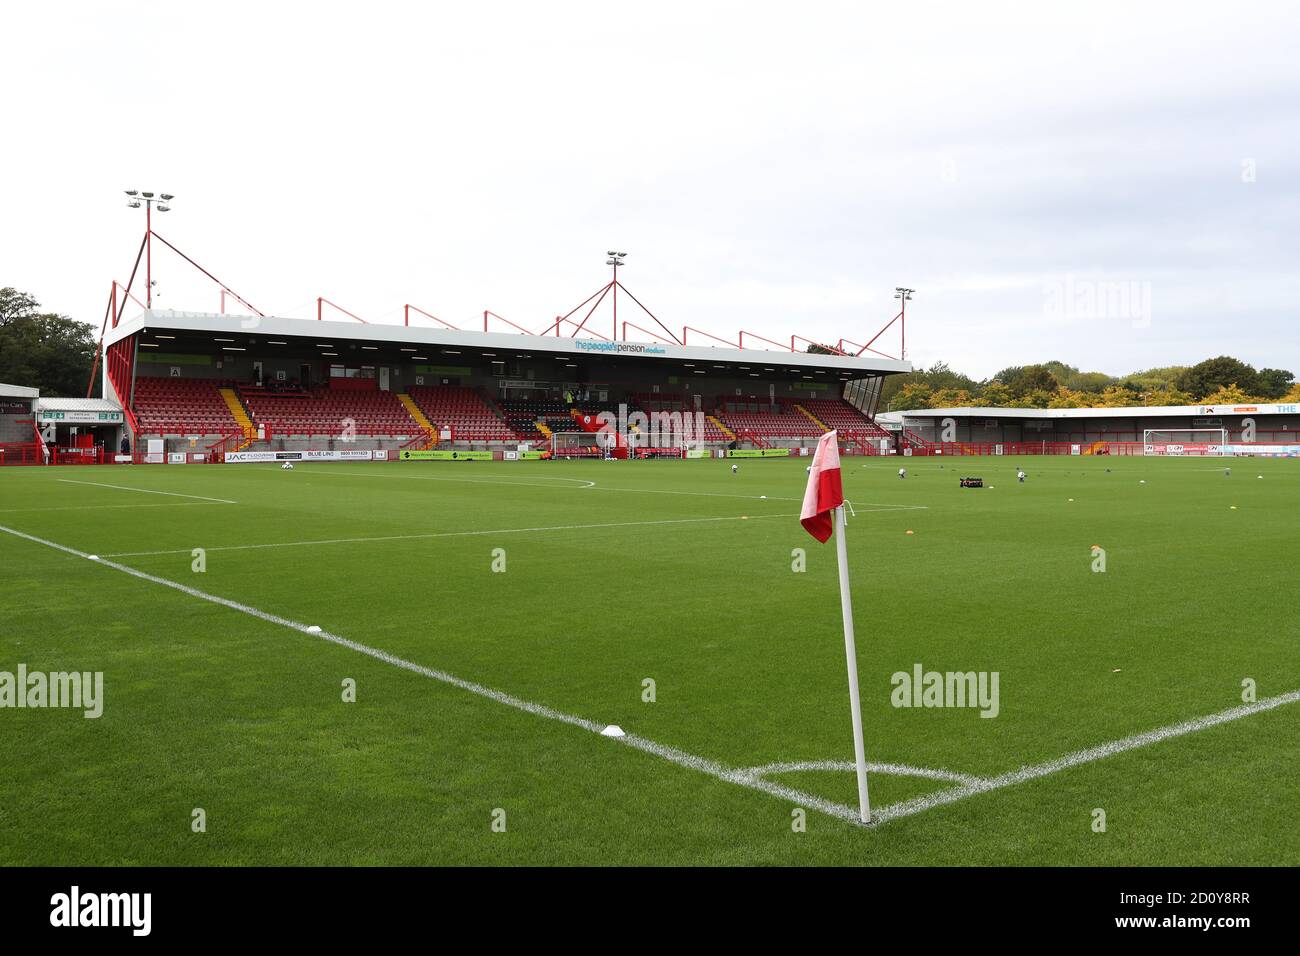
[0,525,858,821]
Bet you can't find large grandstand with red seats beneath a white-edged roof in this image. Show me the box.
[81,310,910,460]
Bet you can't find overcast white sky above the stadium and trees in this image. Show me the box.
[0,0,1300,376]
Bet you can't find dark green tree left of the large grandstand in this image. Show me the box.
[0,289,96,395]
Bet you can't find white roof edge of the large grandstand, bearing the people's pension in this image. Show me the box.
[104,310,911,375]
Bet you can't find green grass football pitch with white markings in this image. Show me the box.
[0,458,1300,865]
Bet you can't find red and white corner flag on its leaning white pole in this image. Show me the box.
[800,432,871,823]
